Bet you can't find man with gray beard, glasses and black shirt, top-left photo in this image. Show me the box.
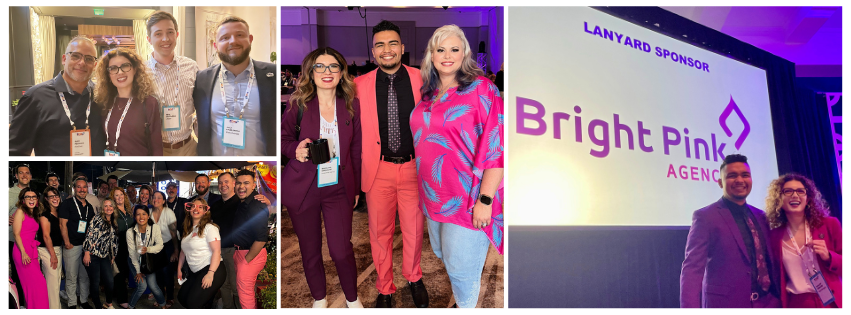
[9,36,106,156]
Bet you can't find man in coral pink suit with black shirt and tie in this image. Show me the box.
[355,21,428,308]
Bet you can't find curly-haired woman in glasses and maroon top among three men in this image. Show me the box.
[95,48,163,156]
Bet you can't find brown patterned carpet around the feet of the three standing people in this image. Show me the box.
[280,210,504,308]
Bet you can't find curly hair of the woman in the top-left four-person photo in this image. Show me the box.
[95,48,156,117]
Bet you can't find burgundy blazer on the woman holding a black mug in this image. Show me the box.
[281,97,361,213]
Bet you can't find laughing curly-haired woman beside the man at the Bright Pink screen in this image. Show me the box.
[765,174,842,308]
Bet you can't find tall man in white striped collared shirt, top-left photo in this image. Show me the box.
[146,11,198,156]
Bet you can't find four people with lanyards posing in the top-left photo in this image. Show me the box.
[9,11,278,156]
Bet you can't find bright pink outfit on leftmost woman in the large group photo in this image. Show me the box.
[12,215,50,309]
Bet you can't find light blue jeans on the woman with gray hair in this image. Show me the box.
[426,219,490,308]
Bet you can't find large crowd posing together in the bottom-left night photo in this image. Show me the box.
[9,165,269,309]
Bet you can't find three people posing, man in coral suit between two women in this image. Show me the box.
[281,21,504,308]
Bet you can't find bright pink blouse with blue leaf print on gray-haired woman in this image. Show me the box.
[411,76,504,254]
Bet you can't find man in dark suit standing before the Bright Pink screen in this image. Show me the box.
[680,154,780,308]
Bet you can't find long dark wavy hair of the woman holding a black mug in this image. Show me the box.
[287,47,357,117]
